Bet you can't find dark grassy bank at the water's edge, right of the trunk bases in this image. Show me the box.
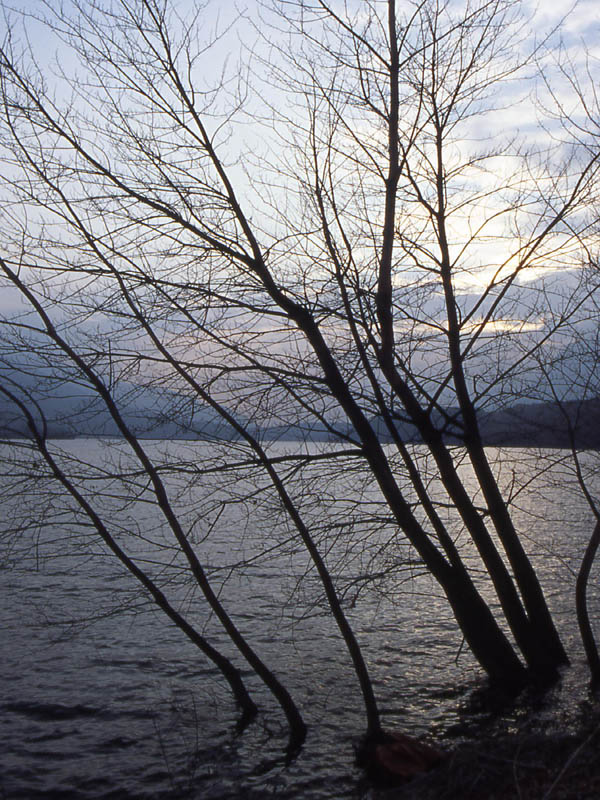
[366,679,600,800]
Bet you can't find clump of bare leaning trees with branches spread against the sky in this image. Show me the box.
[0,0,598,750]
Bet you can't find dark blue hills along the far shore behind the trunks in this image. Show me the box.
[0,376,600,450]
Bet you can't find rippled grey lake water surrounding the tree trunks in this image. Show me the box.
[0,440,598,800]
